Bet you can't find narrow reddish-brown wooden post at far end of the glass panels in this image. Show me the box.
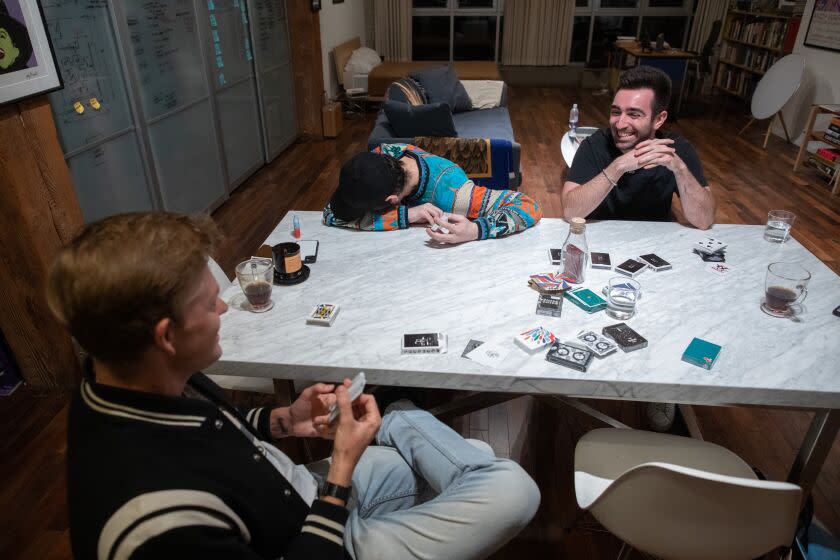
[286,0,324,139]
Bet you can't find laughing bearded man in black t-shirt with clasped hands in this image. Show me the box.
[563,66,715,229]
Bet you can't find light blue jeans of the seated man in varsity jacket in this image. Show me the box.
[311,401,540,560]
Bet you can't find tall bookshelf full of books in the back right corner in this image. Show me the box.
[714,9,800,99]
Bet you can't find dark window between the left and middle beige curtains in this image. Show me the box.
[411,0,502,61]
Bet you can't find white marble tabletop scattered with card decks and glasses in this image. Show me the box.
[210,212,840,408]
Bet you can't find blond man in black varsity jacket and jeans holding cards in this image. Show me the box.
[48,212,539,560]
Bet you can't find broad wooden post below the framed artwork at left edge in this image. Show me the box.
[0,96,83,391]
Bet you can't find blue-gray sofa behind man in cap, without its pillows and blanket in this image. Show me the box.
[368,84,522,187]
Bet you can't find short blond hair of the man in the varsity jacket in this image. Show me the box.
[47,212,219,363]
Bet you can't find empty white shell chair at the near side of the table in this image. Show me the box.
[575,428,802,560]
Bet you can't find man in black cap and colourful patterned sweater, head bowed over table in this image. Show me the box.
[323,144,542,243]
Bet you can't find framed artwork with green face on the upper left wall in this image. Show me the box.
[0,0,63,104]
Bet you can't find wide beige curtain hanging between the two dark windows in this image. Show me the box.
[501,0,575,66]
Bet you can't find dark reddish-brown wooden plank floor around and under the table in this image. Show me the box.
[0,87,840,560]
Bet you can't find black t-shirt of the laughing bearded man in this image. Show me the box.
[566,128,708,222]
